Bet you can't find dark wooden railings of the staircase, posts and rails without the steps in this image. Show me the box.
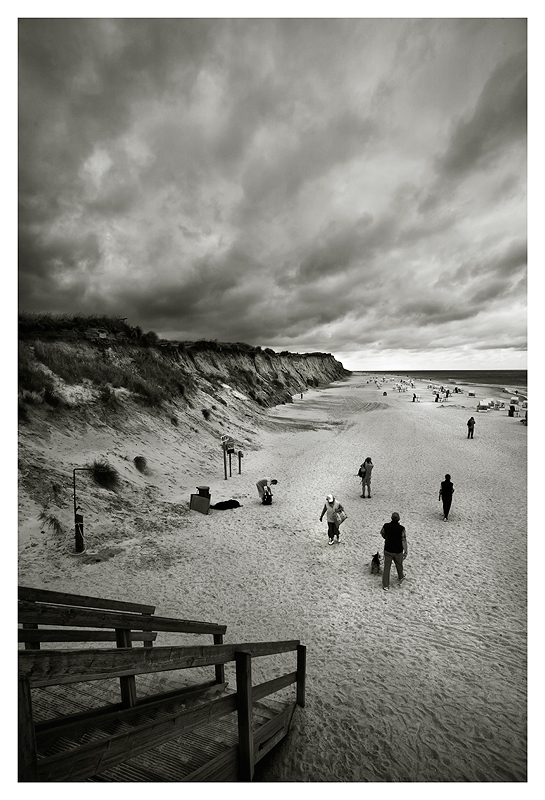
[19,589,306,781]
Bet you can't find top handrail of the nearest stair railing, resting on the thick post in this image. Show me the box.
[18,640,299,686]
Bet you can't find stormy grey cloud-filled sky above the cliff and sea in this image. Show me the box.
[18,18,526,369]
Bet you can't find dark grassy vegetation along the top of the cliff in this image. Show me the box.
[19,313,347,421]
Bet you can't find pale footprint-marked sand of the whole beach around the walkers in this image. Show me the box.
[19,375,527,782]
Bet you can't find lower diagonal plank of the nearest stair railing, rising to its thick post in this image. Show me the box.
[38,695,237,781]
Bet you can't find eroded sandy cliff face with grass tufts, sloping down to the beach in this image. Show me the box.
[18,335,349,564]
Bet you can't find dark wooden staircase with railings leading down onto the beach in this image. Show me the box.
[19,588,306,782]
